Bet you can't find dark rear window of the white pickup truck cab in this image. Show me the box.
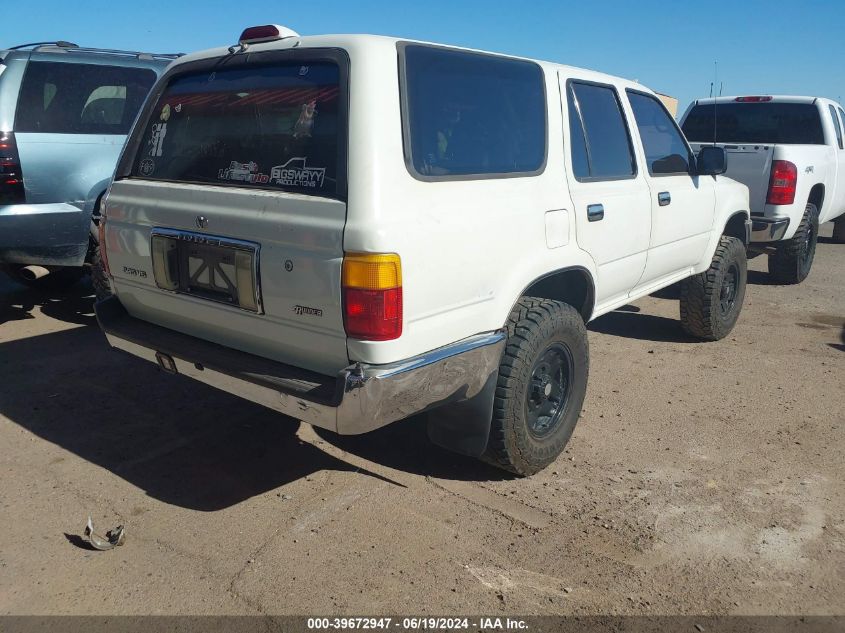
[683,102,824,145]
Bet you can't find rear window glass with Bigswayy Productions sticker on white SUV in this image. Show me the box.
[131,61,340,196]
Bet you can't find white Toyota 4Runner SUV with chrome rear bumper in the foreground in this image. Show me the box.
[97,26,749,474]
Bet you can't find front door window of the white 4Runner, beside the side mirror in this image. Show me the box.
[628,90,692,176]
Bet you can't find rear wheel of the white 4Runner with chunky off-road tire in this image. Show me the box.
[483,297,590,475]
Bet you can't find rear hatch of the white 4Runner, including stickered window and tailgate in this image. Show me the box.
[106,49,348,375]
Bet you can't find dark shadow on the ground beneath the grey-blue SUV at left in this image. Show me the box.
[0,273,96,326]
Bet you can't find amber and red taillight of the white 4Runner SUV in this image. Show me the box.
[341,253,402,341]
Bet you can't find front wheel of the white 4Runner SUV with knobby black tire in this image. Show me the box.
[681,236,748,341]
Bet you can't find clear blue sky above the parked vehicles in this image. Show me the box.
[6,0,845,109]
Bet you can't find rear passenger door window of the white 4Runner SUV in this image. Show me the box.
[567,81,636,180]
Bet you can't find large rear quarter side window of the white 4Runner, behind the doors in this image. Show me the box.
[400,45,546,178]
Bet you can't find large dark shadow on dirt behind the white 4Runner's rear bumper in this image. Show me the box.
[0,326,506,512]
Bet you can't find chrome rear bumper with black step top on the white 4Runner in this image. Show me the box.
[95,296,505,435]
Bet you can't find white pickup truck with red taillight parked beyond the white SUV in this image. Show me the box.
[681,96,845,283]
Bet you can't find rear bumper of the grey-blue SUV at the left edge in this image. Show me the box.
[0,202,91,266]
